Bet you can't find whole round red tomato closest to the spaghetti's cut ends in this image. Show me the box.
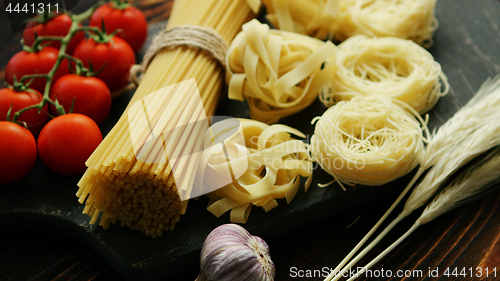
[38,113,102,176]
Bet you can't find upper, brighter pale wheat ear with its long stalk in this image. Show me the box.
[324,76,500,281]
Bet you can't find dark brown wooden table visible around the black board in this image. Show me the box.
[0,0,500,281]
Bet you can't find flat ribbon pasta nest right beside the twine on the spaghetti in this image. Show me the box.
[226,20,336,123]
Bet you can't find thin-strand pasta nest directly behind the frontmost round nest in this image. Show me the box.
[320,35,449,114]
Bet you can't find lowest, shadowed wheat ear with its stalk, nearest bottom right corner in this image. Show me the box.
[348,147,500,281]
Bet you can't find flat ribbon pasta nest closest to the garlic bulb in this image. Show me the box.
[208,119,312,223]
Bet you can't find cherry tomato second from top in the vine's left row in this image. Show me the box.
[5,47,69,93]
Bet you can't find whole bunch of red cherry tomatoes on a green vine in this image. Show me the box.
[0,0,147,184]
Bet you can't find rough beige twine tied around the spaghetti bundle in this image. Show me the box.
[130,25,228,85]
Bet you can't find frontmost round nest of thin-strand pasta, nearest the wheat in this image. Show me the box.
[311,96,428,188]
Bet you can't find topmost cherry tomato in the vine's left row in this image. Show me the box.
[23,14,85,54]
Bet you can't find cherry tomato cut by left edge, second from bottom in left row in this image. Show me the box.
[0,88,49,137]
